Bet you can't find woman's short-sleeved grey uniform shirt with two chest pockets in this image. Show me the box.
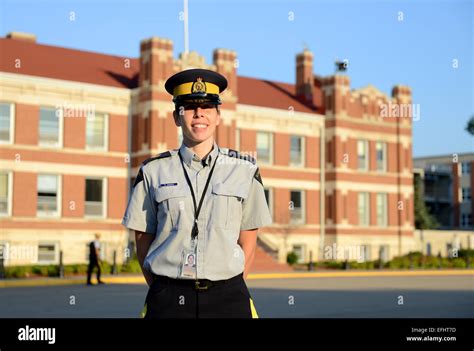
[122,143,272,280]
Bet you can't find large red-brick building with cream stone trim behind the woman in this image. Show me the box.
[0,33,413,264]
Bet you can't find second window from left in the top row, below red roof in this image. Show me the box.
[39,107,62,147]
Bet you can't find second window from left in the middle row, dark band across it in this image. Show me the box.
[37,174,59,216]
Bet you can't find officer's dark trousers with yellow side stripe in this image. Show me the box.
[144,274,258,319]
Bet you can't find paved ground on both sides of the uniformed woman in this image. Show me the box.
[0,275,474,318]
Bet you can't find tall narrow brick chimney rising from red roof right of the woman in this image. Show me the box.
[296,49,314,105]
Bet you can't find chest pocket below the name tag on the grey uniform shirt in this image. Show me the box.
[155,186,190,230]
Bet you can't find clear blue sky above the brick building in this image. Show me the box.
[0,0,474,157]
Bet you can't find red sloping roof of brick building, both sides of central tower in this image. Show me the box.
[0,38,323,113]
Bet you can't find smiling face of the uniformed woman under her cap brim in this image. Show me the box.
[173,103,220,144]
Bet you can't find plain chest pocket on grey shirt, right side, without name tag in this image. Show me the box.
[212,183,247,231]
